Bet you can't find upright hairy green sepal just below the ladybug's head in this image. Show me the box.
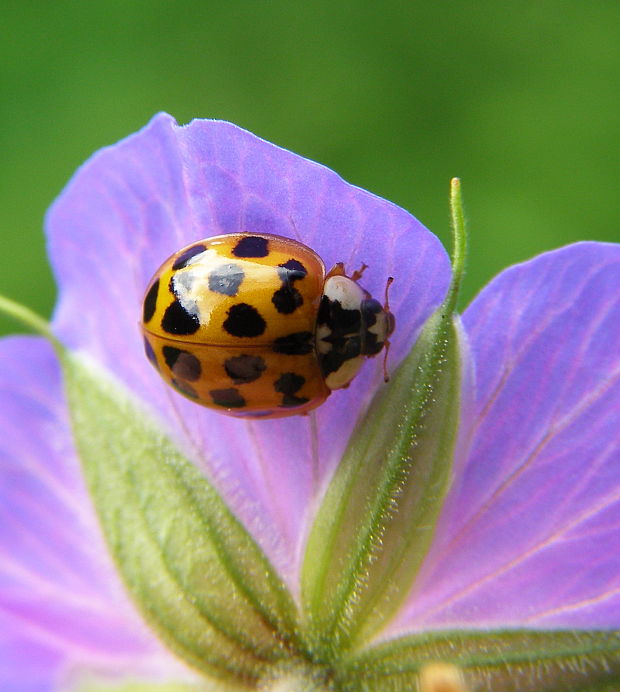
[301,305,461,660]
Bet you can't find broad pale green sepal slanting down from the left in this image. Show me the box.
[59,351,297,689]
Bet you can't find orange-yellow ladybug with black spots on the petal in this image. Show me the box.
[142,233,394,418]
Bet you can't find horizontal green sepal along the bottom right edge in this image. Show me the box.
[336,630,620,692]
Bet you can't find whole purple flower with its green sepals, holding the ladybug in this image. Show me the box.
[0,115,620,691]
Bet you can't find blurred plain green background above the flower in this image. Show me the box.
[0,0,620,332]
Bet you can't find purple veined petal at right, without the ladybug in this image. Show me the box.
[394,243,620,629]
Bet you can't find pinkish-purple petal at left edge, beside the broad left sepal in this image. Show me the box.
[0,337,196,690]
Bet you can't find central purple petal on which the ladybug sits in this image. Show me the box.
[48,115,450,588]
